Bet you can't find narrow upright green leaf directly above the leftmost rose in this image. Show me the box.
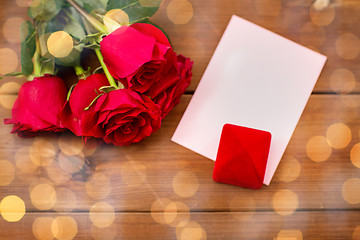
[20,21,36,75]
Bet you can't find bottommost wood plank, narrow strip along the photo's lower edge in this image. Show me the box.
[0,211,360,240]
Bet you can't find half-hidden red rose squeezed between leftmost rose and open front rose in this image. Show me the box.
[60,73,109,136]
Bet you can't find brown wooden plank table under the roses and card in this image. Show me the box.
[0,0,360,240]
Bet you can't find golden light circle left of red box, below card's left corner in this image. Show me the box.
[172,171,199,198]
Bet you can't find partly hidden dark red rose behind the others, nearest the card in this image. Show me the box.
[153,55,193,118]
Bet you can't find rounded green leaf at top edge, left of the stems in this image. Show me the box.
[28,0,64,22]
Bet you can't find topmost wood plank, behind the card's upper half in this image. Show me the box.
[0,0,360,92]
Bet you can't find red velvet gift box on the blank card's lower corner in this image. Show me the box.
[213,124,271,189]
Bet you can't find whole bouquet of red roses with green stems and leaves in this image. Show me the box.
[5,0,193,146]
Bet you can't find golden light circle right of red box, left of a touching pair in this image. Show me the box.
[306,136,332,162]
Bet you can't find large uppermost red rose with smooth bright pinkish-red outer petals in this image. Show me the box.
[100,23,179,98]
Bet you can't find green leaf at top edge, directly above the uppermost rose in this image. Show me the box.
[106,0,161,23]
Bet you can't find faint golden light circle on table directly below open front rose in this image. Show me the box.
[121,161,146,187]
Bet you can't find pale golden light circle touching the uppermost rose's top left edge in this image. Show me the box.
[103,9,130,32]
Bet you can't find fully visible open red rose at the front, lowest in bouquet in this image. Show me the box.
[81,89,161,146]
